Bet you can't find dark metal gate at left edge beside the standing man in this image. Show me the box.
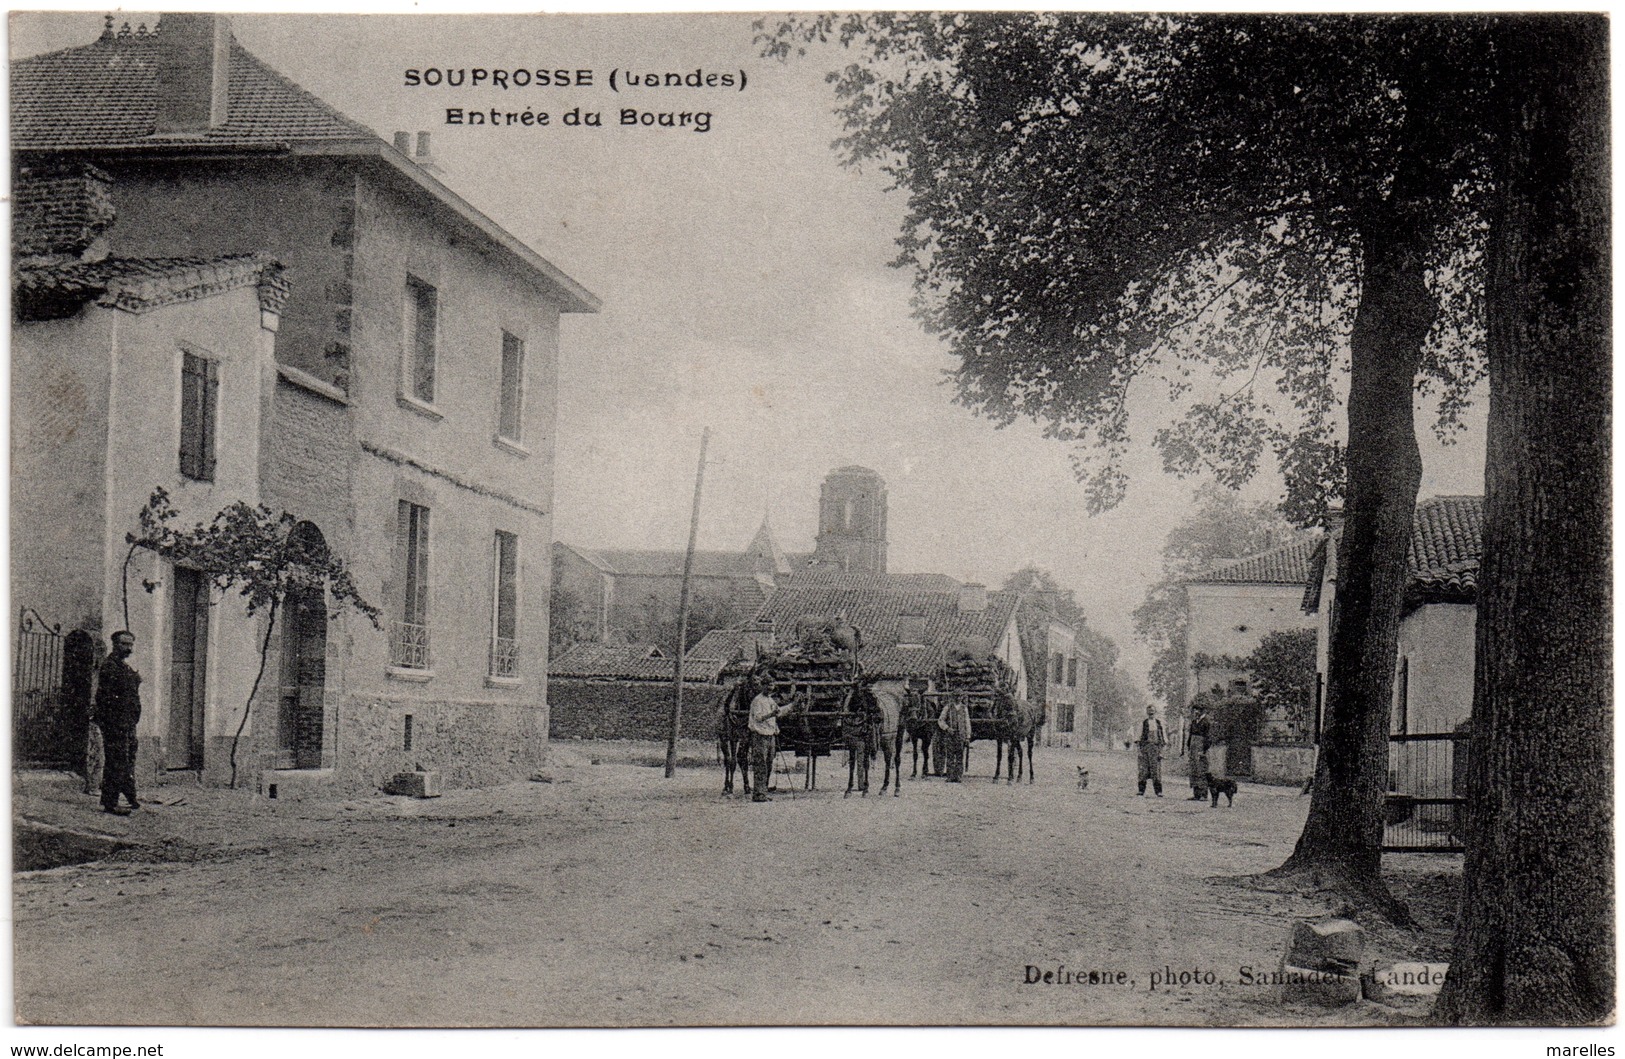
[11,606,96,768]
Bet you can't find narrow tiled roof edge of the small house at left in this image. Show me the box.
[13,253,288,320]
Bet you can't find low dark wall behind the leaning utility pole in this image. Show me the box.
[548,677,722,741]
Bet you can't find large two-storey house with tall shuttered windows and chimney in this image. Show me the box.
[11,15,598,797]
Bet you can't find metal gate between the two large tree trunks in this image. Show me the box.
[1383,733,1467,853]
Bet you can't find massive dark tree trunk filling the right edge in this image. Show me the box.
[1438,16,1615,1025]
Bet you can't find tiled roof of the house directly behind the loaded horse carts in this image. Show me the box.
[756,575,1019,677]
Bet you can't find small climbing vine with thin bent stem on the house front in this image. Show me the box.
[124,487,379,786]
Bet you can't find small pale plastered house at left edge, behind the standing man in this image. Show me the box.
[10,181,288,778]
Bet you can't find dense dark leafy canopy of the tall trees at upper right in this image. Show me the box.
[761,13,1485,525]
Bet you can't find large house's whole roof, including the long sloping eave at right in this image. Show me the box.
[10,19,600,312]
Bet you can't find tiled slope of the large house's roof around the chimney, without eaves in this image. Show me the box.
[11,24,379,151]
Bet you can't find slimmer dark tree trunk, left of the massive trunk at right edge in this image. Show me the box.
[1277,195,1437,916]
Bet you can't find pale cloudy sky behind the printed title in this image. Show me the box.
[11,13,1484,681]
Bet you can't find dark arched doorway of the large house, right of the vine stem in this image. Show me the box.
[276,521,327,768]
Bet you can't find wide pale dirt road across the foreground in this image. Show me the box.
[15,747,1462,1027]
